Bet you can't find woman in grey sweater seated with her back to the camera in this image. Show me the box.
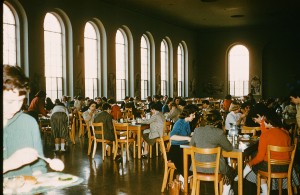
[190,110,236,195]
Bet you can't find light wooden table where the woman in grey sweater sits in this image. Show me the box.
[180,139,259,195]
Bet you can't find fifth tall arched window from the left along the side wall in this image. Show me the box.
[141,35,150,99]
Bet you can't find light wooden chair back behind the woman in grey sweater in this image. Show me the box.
[191,146,221,180]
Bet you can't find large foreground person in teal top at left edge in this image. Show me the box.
[3,65,47,177]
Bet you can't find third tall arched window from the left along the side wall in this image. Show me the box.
[84,22,99,99]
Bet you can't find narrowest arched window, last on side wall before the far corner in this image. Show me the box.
[177,43,185,96]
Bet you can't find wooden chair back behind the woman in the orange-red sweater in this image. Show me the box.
[267,139,297,178]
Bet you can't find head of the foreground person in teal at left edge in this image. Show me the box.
[3,65,30,119]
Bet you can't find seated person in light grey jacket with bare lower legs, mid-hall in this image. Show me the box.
[142,103,166,158]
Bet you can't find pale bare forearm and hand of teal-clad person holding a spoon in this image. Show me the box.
[3,148,38,172]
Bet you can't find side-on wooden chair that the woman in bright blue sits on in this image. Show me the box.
[156,136,176,192]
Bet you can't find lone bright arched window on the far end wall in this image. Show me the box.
[228,45,249,96]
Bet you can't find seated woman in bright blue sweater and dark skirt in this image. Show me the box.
[168,104,196,182]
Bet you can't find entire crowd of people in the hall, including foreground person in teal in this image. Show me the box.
[3,65,300,194]
